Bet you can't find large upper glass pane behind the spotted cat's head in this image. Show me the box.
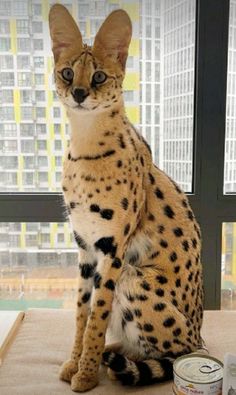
[0,0,196,192]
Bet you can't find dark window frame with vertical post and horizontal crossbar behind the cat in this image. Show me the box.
[0,0,232,309]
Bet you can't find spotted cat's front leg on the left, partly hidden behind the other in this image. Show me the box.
[59,248,97,382]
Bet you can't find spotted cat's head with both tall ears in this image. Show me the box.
[49,4,132,113]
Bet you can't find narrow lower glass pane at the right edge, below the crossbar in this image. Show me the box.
[221,222,236,310]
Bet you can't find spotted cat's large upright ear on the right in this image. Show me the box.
[93,10,132,70]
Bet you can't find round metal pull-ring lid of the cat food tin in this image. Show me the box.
[174,353,223,384]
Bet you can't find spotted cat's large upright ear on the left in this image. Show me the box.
[49,4,83,63]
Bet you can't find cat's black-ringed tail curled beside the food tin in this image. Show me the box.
[103,351,174,386]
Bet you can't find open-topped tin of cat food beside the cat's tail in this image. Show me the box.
[173,353,223,395]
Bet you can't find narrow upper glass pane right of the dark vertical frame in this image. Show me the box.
[224,0,236,194]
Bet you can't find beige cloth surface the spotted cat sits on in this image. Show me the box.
[0,309,236,395]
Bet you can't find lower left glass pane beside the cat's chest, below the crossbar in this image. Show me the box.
[0,222,78,310]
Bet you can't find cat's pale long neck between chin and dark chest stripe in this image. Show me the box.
[68,103,127,157]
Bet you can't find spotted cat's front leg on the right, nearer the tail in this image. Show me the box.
[71,251,122,392]
